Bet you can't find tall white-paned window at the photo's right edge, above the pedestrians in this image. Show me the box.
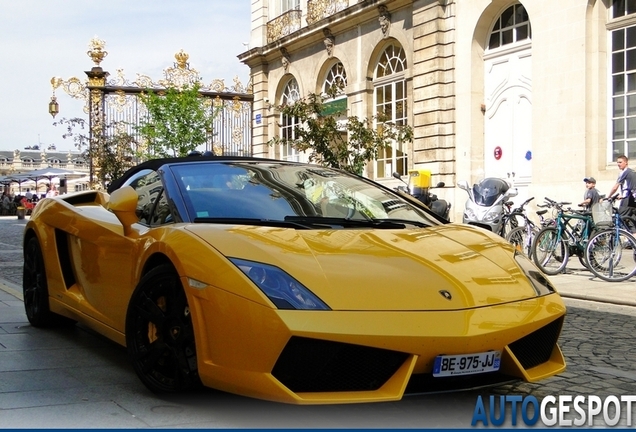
[609,0,636,161]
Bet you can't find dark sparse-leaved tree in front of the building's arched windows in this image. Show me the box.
[269,90,413,175]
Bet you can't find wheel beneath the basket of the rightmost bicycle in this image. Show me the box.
[585,228,636,282]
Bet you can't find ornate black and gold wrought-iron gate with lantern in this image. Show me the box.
[49,37,254,184]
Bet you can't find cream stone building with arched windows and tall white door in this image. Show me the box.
[239,0,636,220]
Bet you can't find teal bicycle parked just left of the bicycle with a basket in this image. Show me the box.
[532,197,594,275]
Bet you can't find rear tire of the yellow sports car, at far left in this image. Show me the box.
[22,237,75,328]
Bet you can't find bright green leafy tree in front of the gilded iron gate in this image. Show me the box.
[137,84,216,157]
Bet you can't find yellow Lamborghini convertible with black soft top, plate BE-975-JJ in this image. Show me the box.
[23,156,566,404]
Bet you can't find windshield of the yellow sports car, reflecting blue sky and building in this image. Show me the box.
[170,161,439,226]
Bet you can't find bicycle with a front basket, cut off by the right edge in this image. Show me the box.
[585,196,636,282]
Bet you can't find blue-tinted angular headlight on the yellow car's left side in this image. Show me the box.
[228,258,330,310]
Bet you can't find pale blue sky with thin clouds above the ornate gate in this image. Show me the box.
[0,0,251,151]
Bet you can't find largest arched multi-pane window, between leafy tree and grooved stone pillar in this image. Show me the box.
[374,43,408,178]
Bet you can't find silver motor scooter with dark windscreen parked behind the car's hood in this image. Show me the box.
[457,177,518,235]
